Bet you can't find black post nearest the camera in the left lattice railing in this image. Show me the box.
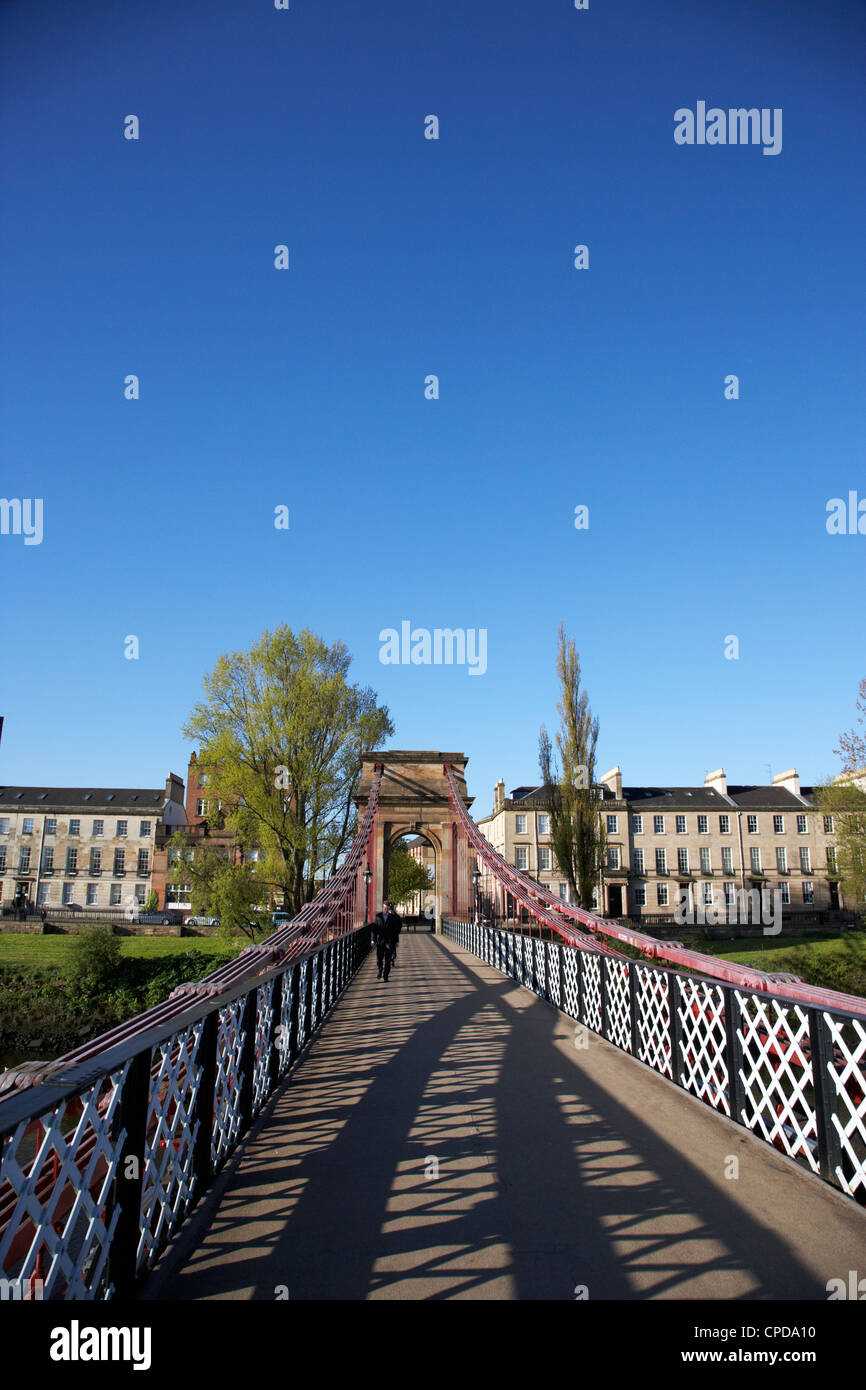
[108,1048,150,1298]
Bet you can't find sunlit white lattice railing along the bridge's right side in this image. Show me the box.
[443,920,866,1205]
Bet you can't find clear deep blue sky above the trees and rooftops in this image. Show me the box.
[0,0,866,813]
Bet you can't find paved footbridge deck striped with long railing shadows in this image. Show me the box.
[146,933,866,1301]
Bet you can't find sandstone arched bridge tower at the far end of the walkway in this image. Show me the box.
[354,749,474,922]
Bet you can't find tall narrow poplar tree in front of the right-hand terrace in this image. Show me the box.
[538,623,605,909]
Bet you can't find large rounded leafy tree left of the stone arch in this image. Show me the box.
[183,624,393,912]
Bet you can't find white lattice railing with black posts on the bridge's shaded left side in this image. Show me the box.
[0,929,370,1300]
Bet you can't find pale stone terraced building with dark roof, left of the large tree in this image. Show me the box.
[0,773,186,913]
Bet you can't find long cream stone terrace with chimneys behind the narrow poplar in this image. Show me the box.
[478,767,853,923]
